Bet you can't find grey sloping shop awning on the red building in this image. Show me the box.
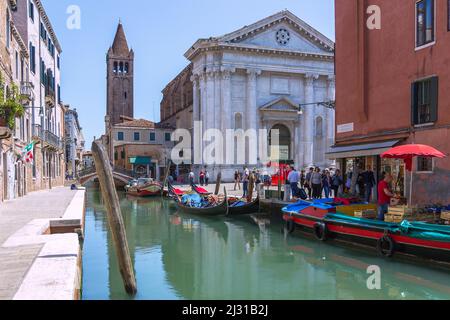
[326,140,401,160]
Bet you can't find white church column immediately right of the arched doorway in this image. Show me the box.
[303,74,319,166]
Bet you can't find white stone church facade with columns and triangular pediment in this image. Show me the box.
[161,10,335,180]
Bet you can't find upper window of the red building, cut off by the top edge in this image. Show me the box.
[416,0,434,47]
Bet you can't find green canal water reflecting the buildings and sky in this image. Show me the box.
[82,188,450,300]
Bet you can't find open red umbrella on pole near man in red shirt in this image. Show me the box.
[381,144,445,204]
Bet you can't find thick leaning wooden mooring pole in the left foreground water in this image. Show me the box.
[92,141,137,295]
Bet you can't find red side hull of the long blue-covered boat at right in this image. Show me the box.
[283,213,450,264]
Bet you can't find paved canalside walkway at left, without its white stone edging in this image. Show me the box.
[0,187,76,300]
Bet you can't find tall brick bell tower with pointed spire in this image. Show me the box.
[106,22,134,125]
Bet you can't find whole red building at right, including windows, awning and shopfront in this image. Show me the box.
[328,0,450,203]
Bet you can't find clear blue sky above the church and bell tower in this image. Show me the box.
[42,0,334,149]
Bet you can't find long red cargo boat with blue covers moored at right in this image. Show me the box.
[283,201,450,264]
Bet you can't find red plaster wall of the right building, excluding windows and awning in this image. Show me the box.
[335,0,450,203]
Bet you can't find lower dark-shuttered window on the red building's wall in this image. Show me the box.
[411,77,438,125]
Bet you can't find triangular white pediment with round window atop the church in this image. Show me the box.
[217,10,334,54]
